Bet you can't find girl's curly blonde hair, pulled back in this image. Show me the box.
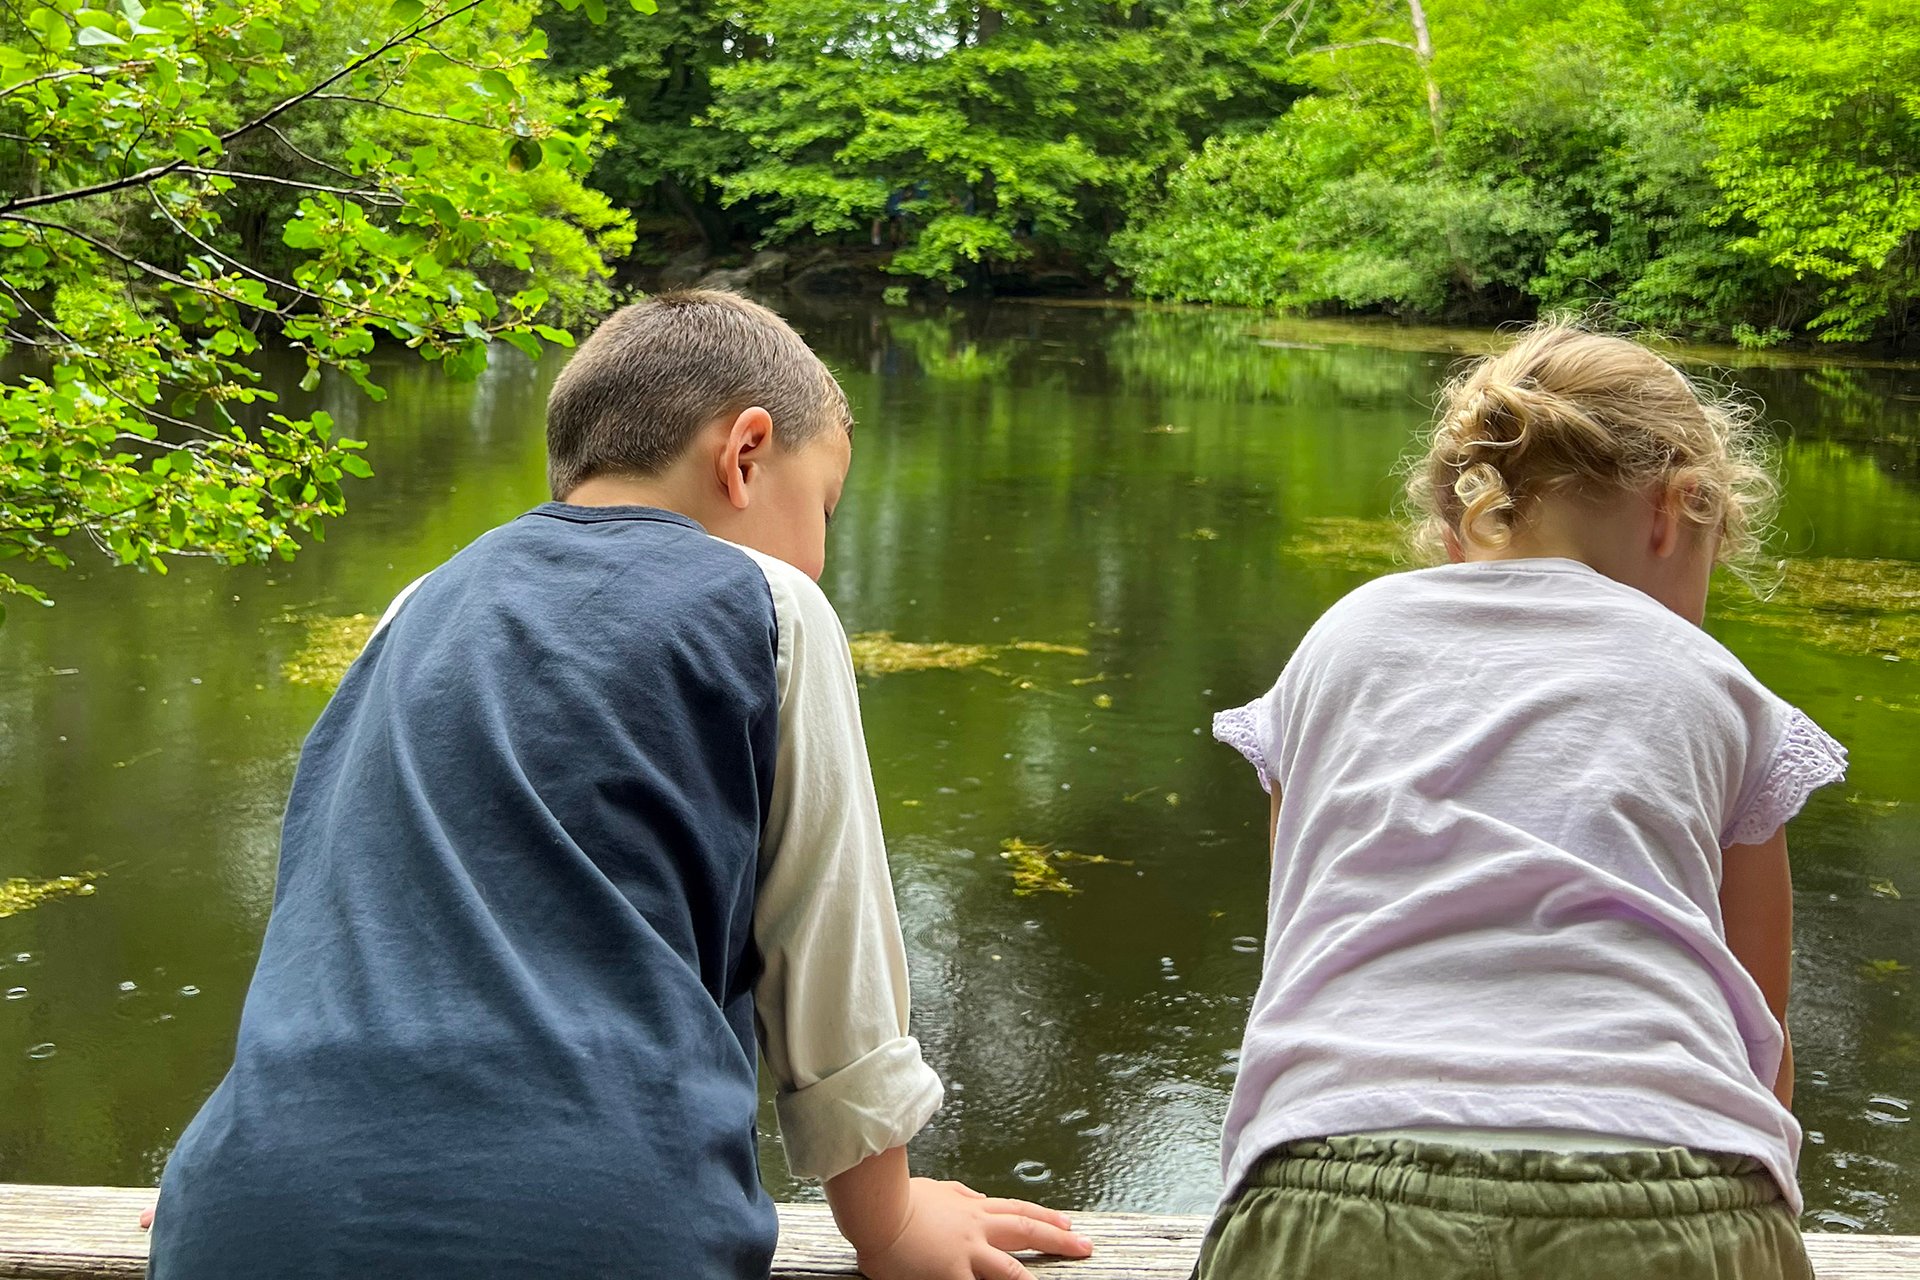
[1407,320,1778,564]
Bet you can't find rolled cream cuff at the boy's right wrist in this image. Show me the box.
[774,1036,945,1178]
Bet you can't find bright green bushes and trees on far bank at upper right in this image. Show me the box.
[1114,0,1920,344]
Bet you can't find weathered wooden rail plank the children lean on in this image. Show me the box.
[0,1184,1920,1280]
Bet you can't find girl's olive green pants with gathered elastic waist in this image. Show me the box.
[1194,1138,1812,1280]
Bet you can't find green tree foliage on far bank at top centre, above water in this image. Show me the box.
[708,0,1279,288]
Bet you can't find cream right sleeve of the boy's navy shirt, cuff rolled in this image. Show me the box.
[747,551,941,1178]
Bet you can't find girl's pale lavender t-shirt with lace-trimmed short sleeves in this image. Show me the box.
[1213,558,1845,1211]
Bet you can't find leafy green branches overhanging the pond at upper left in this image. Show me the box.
[0,0,639,599]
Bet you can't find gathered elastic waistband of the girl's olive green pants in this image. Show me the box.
[1244,1138,1782,1219]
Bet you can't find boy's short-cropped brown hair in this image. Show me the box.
[547,290,852,499]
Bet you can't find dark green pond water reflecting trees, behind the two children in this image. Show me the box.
[0,305,1920,1232]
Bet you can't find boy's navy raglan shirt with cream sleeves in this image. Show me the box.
[150,503,941,1280]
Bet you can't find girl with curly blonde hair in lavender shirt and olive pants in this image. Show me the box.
[1198,324,1845,1280]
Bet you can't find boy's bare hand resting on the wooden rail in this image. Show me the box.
[858,1178,1092,1280]
